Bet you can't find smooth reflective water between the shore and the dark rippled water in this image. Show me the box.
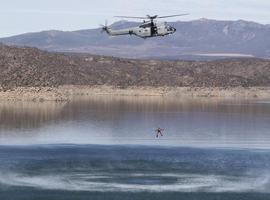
[0,96,270,148]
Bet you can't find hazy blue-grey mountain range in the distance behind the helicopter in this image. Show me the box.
[0,19,270,60]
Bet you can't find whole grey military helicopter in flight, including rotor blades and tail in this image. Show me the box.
[101,14,188,39]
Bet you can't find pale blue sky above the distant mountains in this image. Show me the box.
[0,0,270,37]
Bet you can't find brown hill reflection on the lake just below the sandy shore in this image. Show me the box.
[0,96,270,129]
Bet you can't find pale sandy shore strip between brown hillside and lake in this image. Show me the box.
[0,86,270,101]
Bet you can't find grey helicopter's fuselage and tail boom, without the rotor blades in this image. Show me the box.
[104,22,176,38]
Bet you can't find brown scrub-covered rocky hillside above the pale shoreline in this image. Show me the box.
[0,45,270,89]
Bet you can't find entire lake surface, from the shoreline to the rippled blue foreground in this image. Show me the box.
[0,97,270,200]
